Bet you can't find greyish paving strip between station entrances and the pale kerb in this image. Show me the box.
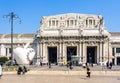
[30,65,120,71]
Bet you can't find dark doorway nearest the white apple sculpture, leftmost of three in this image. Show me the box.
[48,47,57,64]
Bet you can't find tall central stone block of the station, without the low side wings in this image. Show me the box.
[36,13,112,64]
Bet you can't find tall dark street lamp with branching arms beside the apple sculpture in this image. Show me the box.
[3,12,21,65]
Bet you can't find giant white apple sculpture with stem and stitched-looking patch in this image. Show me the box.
[13,44,35,64]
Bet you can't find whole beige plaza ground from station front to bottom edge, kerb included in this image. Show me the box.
[0,65,120,83]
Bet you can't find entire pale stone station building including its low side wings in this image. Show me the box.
[0,13,120,65]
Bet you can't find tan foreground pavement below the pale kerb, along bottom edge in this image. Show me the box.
[0,75,120,83]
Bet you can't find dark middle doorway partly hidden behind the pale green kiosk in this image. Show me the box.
[67,46,77,61]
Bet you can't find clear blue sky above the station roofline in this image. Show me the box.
[0,0,120,34]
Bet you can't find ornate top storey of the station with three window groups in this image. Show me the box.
[41,14,104,29]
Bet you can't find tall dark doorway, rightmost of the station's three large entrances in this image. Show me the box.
[87,46,97,64]
